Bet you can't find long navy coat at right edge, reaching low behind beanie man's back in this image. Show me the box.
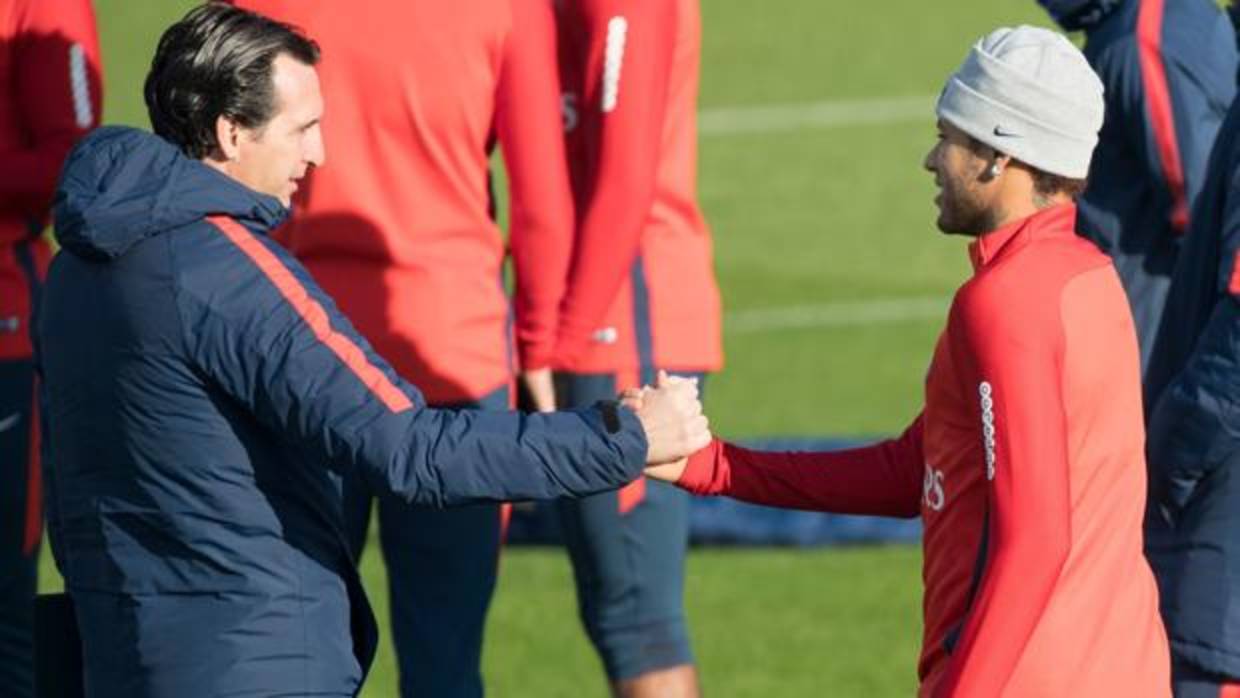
[1146,95,1240,679]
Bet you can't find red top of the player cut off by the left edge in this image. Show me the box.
[0,0,100,360]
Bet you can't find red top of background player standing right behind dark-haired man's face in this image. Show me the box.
[237,0,572,403]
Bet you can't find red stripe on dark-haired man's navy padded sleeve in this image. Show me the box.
[207,216,413,412]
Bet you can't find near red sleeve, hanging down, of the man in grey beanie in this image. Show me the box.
[935,279,1071,696]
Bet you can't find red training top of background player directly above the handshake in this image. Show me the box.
[553,0,723,373]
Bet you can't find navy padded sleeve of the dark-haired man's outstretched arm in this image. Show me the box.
[179,223,646,506]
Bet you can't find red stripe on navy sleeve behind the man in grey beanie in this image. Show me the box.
[1137,0,1188,233]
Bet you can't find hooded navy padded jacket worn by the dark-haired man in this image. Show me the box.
[37,128,646,698]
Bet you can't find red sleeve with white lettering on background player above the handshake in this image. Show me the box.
[556,0,676,363]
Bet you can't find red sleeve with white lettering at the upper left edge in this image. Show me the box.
[0,0,102,221]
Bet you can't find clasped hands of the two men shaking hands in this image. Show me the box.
[620,371,711,481]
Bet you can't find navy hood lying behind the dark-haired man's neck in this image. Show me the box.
[52,126,288,260]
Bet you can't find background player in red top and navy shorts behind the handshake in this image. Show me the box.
[547,0,723,697]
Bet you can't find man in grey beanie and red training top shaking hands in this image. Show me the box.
[647,27,1171,697]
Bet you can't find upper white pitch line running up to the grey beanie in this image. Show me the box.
[698,95,936,135]
